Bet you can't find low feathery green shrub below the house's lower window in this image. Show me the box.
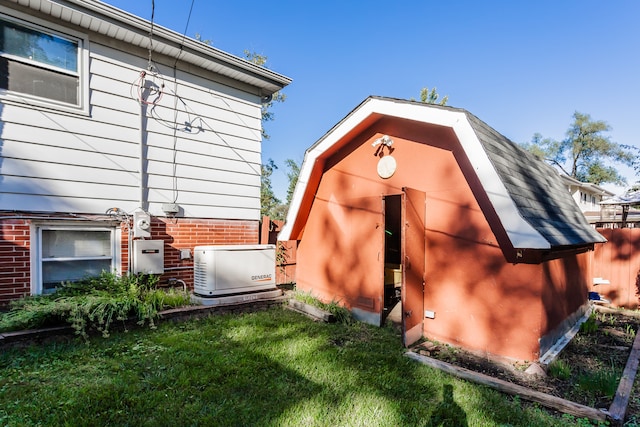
[0,272,189,338]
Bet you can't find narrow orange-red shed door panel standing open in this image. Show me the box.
[401,187,426,347]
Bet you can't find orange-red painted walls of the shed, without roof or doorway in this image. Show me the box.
[297,122,586,360]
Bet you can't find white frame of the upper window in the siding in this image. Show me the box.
[0,6,89,114]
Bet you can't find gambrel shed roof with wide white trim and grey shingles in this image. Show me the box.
[280,97,606,249]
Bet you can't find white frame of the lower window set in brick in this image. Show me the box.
[30,222,122,295]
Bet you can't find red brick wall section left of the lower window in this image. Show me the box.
[0,217,31,306]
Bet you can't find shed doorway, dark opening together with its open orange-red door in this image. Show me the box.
[382,187,426,347]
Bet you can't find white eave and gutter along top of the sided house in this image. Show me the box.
[10,0,291,96]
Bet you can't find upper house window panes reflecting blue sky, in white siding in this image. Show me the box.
[0,16,82,106]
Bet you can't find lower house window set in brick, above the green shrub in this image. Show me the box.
[32,226,120,294]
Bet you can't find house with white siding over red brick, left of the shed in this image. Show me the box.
[0,0,291,304]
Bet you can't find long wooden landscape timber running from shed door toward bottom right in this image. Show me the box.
[405,351,608,421]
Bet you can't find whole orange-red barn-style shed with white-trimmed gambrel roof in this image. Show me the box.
[280,97,605,360]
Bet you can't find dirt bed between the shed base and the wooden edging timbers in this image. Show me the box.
[413,311,640,421]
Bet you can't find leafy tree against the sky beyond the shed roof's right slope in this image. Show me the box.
[523,111,637,185]
